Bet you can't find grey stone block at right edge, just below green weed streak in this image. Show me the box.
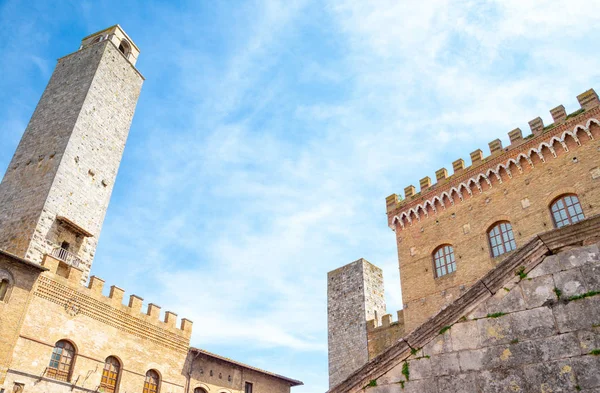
[553,296,600,333]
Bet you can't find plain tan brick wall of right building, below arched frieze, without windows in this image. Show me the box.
[388,107,600,331]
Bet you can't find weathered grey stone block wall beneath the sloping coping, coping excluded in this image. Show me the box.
[365,244,600,393]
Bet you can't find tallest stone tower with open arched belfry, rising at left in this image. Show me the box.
[0,25,144,280]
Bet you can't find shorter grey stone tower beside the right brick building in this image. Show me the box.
[327,258,386,387]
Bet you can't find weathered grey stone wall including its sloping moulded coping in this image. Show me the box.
[329,215,600,393]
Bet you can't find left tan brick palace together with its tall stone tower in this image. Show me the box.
[0,25,302,393]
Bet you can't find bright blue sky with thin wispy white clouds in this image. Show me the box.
[0,0,600,393]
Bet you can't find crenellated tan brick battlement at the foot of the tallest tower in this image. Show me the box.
[36,255,192,351]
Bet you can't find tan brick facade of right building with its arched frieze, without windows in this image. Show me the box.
[387,94,600,331]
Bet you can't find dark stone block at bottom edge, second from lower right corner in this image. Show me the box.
[524,359,577,393]
